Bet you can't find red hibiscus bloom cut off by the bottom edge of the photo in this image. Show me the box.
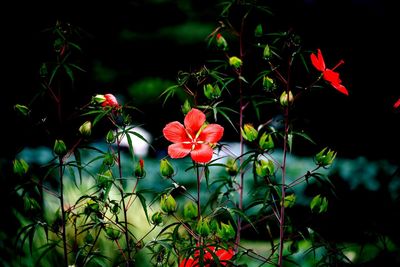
[179,246,234,267]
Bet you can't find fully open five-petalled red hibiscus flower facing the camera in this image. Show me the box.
[163,108,224,163]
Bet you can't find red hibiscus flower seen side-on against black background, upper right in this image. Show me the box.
[311,49,349,95]
